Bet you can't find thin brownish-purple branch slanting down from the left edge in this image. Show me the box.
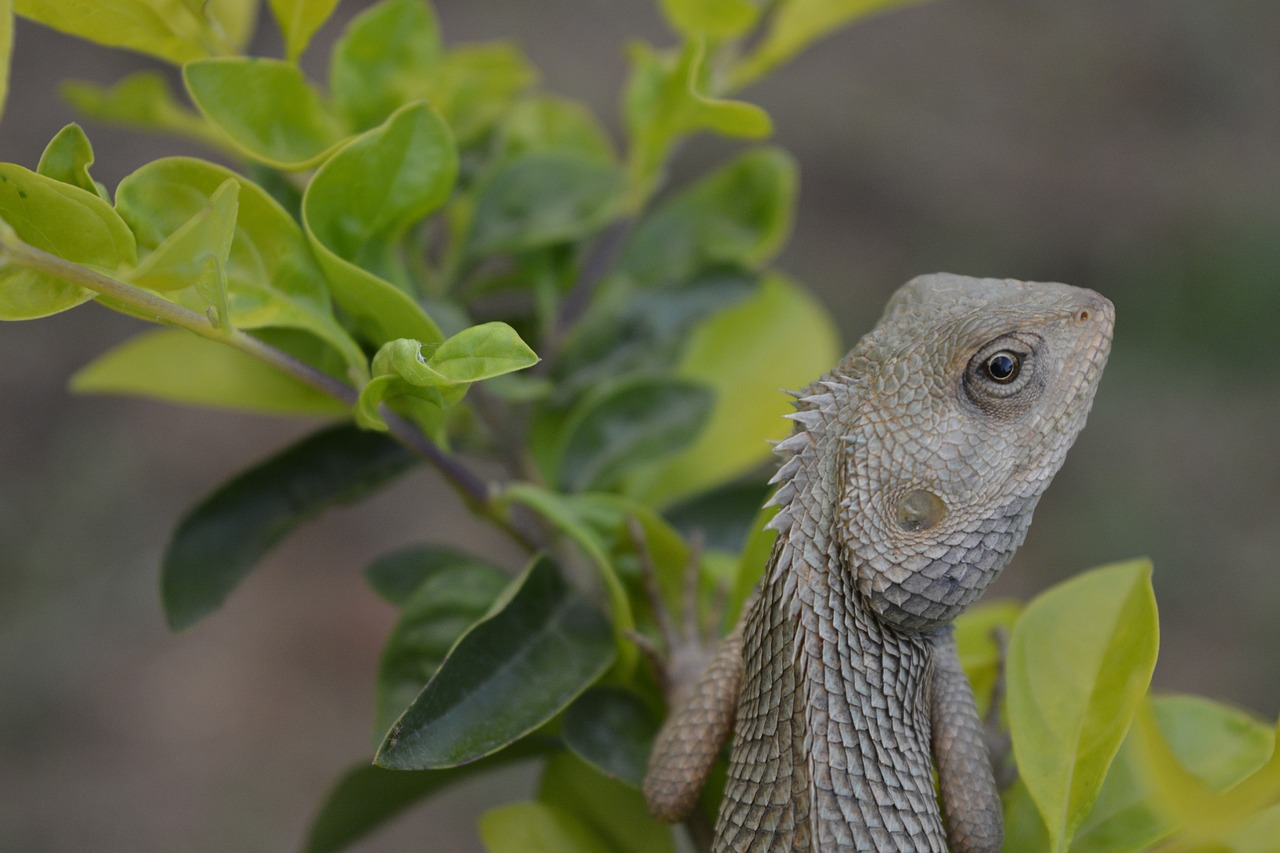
[0,229,539,552]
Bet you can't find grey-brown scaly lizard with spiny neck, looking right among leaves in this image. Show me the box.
[644,273,1115,853]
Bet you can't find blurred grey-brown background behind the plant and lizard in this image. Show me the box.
[0,0,1280,853]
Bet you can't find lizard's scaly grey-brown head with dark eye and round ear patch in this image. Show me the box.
[827,274,1115,631]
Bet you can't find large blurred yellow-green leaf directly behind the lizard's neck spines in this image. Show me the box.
[628,273,840,505]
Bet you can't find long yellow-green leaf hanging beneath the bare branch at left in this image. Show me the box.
[70,329,347,416]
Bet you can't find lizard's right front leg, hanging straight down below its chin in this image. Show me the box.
[929,625,1004,853]
